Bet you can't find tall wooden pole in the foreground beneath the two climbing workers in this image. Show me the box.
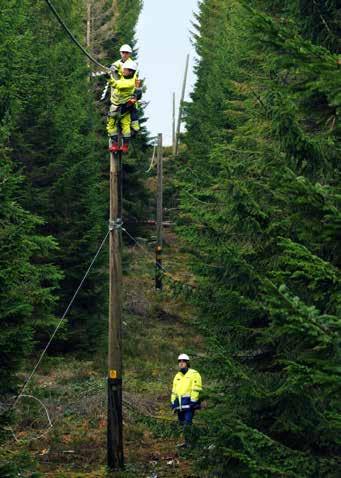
[107,141,124,470]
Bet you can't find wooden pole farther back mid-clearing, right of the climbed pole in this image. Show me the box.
[155,133,163,290]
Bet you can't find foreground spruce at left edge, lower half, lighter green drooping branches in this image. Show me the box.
[0,157,61,398]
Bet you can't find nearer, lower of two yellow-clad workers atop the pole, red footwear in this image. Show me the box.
[107,58,140,153]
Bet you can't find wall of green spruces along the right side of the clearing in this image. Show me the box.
[178,0,341,477]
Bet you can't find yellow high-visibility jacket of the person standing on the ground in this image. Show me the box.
[171,368,202,410]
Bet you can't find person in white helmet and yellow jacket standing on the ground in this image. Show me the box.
[171,354,202,447]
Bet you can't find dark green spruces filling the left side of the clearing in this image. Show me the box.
[0,0,148,404]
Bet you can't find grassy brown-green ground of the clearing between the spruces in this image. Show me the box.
[3,236,203,478]
